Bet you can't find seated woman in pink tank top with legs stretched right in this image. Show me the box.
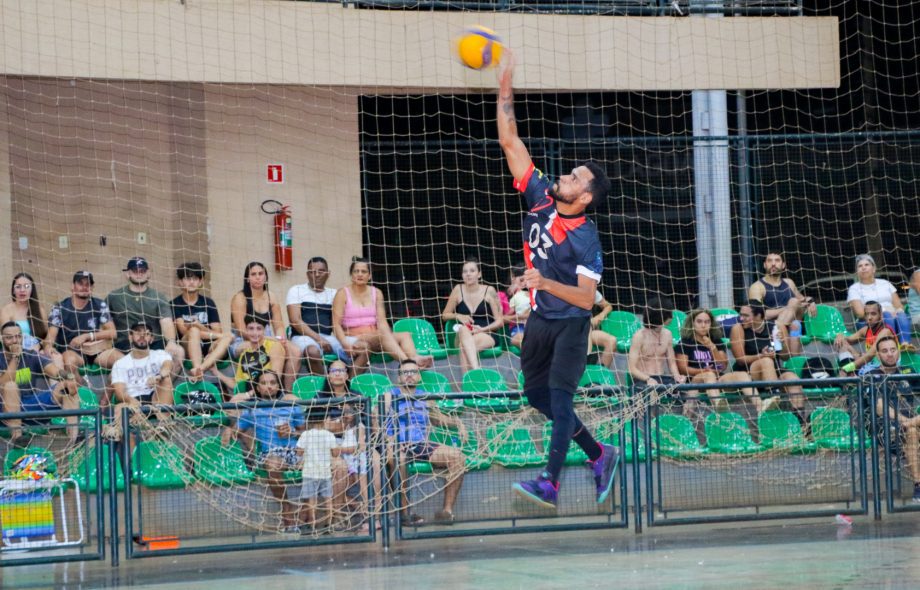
[332,257,432,373]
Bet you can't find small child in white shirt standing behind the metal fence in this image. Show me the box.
[297,422,341,530]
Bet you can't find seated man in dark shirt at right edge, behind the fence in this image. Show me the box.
[868,335,920,504]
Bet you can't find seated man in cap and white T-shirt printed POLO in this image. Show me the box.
[103,322,173,440]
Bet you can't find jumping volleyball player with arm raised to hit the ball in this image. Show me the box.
[497,51,619,508]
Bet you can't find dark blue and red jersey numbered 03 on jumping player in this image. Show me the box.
[514,164,604,320]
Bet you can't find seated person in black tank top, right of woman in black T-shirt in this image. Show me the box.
[729,301,806,425]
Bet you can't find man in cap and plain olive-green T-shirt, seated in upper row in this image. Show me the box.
[106,256,185,375]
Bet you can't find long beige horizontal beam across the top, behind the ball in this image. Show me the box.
[0,0,840,90]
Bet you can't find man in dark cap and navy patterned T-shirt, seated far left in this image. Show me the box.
[42,270,124,388]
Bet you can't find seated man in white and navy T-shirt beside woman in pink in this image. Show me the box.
[286,256,348,375]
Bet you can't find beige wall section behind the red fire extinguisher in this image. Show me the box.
[205,85,361,321]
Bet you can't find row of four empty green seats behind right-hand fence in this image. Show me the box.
[652,407,869,459]
